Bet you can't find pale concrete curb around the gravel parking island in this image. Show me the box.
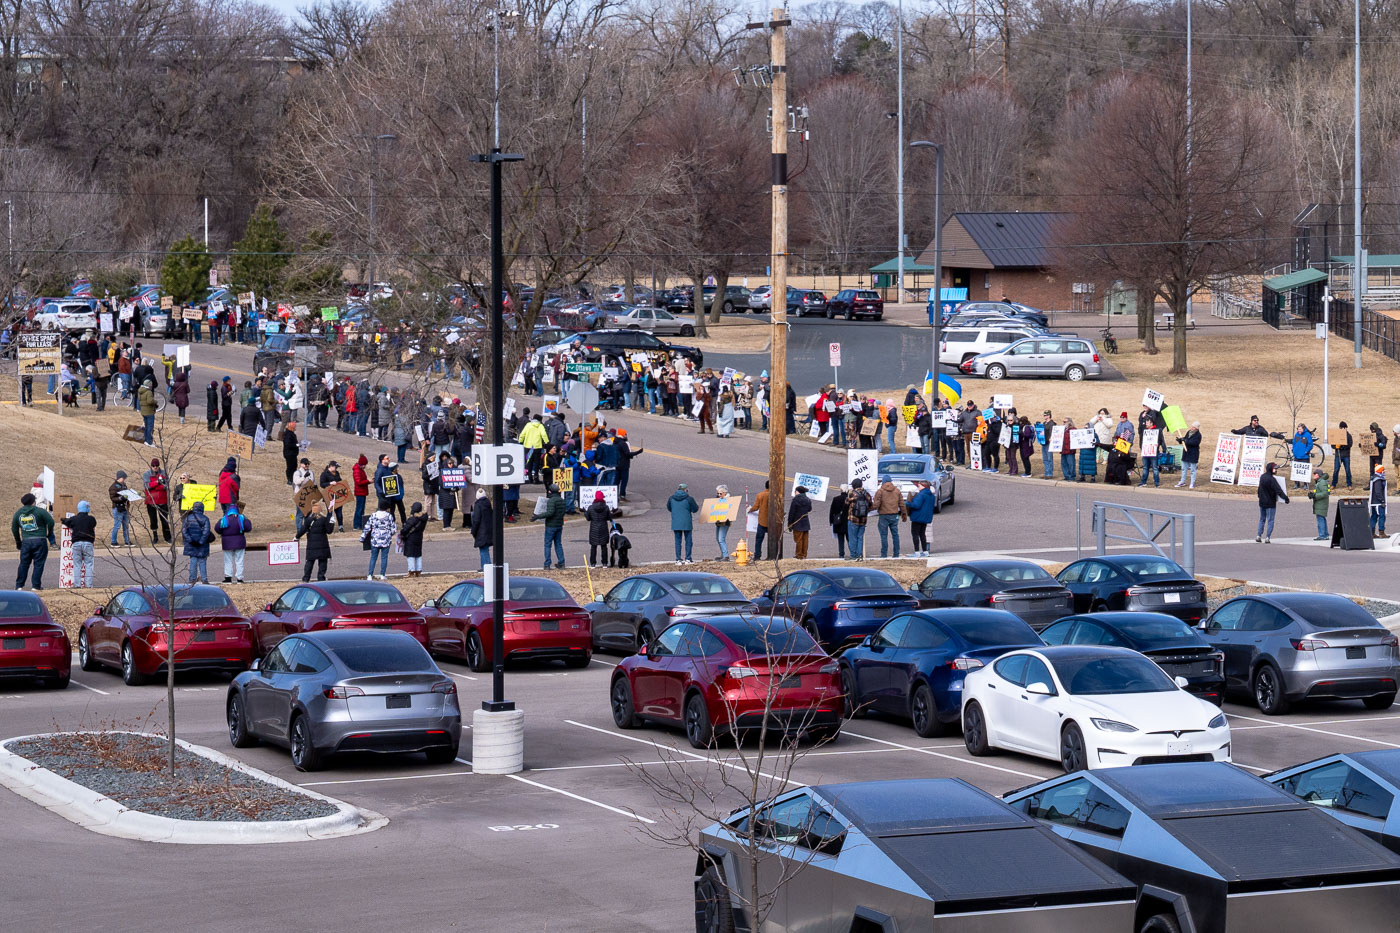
[0,733,389,845]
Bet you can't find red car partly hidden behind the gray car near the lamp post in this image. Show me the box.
[252,580,428,657]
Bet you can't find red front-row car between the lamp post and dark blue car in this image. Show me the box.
[609,614,841,748]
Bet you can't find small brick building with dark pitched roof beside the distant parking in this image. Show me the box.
[917,210,1084,311]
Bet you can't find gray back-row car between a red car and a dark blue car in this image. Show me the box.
[584,570,753,651]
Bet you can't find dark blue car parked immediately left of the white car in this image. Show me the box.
[840,609,1040,738]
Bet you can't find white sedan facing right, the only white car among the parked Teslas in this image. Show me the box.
[962,644,1229,770]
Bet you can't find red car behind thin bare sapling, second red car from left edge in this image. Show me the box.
[78,584,253,686]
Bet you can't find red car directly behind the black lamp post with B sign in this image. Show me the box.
[421,577,594,671]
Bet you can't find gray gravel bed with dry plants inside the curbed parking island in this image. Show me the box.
[6,733,336,822]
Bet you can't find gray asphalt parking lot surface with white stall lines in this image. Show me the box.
[8,656,1400,930]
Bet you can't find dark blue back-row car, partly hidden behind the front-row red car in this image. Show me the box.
[753,567,918,649]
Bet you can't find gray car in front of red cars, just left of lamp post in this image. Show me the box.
[224,629,462,770]
